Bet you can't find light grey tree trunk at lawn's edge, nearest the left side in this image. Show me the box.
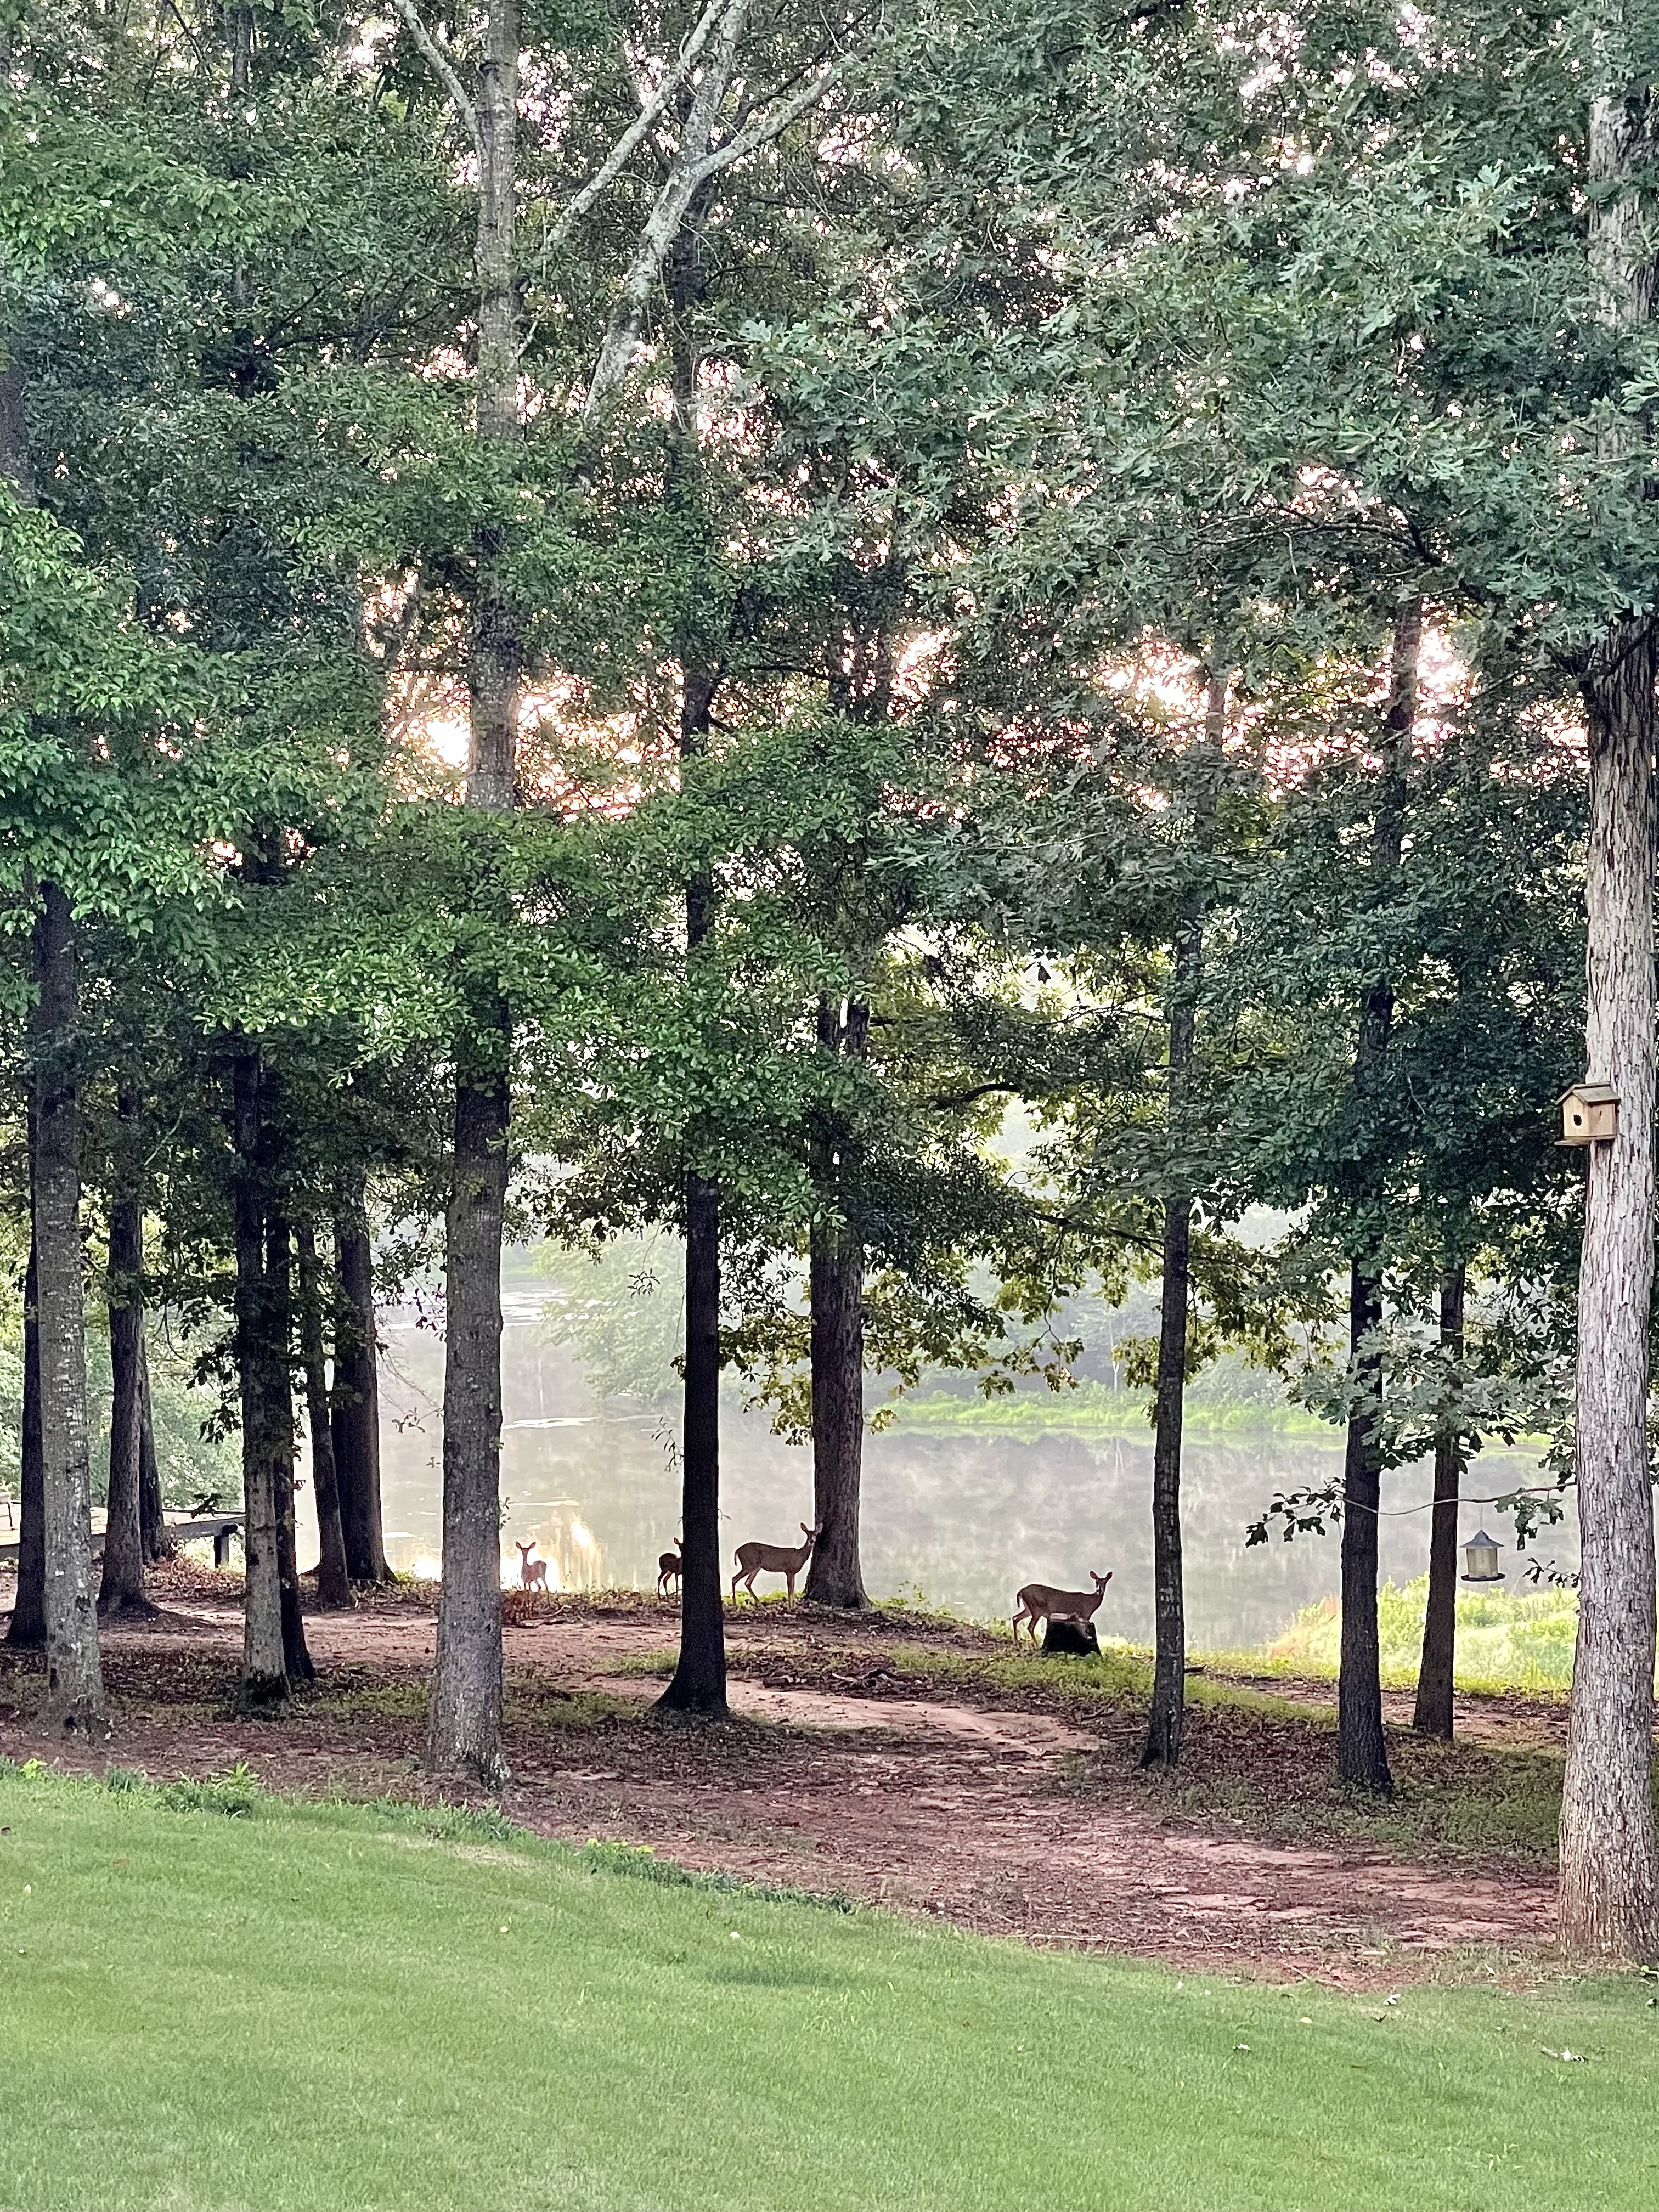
[33,883,104,1734]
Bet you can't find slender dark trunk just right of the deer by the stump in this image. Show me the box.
[1142,675,1228,1768]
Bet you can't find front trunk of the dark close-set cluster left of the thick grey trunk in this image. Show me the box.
[230,1037,287,1708]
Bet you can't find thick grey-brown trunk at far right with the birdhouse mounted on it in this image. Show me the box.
[1560,617,1659,1960]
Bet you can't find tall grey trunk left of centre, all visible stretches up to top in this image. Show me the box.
[427,0,524,1783]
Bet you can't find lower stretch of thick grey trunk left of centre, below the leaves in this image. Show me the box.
[427,1048,509,1787]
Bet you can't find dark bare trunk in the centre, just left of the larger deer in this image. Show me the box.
[659,1175,725,1721]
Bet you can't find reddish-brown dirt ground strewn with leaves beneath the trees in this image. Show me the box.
[0,1566,1558,1987]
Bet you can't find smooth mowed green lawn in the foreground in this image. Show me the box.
[0,1768,1659,2212]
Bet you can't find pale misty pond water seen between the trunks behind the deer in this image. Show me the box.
[301,1290,1577,1650]
